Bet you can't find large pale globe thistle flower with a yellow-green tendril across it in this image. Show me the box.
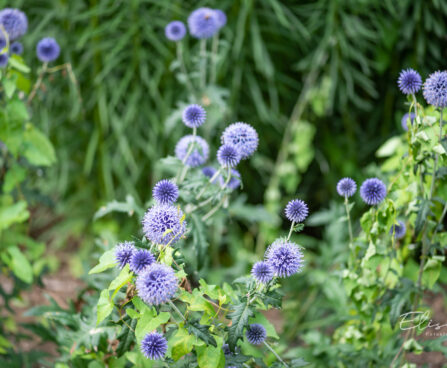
[142,204,186,245]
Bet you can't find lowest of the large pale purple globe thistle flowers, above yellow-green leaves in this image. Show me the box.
[135,263,178,305]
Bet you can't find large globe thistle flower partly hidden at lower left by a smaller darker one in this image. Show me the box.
[222,122,259,159]
